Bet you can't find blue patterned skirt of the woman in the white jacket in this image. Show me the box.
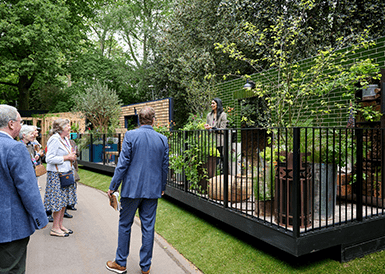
[44,171,77,212]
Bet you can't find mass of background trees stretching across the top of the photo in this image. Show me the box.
[0,0,385,130]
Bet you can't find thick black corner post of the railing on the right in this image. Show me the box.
[289,128,301,238]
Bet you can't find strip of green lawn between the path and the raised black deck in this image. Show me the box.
[79,168,385,274]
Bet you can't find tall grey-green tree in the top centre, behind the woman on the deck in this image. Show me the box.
[152,0,245,127]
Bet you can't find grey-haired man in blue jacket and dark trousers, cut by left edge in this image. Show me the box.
[0,105,48,273]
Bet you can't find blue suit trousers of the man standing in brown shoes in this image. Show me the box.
[115,198,158,271]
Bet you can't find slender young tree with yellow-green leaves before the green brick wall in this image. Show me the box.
[216,1,378,127]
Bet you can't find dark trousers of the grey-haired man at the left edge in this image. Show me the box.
[0,237,29,274]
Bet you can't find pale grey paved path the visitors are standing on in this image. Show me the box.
[26,176,202,274]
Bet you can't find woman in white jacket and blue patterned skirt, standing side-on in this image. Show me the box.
[44,119,76,237]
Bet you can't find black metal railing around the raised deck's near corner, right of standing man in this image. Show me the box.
[168,128,384,236]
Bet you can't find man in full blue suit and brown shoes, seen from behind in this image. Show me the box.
[106,107,168,274]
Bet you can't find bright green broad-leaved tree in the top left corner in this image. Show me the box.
[0,0,97,110]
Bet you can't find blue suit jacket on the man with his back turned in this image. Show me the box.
[110,125,168,199]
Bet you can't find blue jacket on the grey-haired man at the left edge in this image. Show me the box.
[0,131,48,243]
